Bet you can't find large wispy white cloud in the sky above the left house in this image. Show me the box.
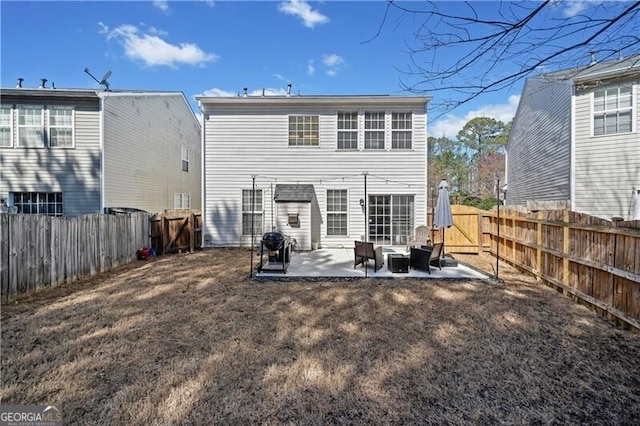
[99,23,219,67]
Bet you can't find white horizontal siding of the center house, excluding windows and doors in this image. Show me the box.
[203,103,426,247]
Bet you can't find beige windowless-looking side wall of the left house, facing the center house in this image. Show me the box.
[103,93,201,212]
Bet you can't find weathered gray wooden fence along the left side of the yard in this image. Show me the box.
[0,212,149,302]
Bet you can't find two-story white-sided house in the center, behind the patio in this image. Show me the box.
[198,96,429,250]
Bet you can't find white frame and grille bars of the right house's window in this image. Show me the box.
[591,83,636,136]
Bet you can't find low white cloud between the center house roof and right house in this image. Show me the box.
[429,95,520,139]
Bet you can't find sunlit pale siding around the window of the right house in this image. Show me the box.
[572,80,640,219]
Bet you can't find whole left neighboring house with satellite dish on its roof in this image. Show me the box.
[0,83,201,216]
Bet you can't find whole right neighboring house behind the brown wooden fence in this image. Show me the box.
[506,55,640,219]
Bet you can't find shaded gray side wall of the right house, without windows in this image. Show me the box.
[506,77,572,205]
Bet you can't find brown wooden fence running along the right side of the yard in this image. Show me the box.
[482,207,640,329]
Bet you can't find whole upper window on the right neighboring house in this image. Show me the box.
[593,83,633,136]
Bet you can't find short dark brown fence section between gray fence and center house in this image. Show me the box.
[149,209,202,254]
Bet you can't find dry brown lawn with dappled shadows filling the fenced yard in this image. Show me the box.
[1,249,640,425]
